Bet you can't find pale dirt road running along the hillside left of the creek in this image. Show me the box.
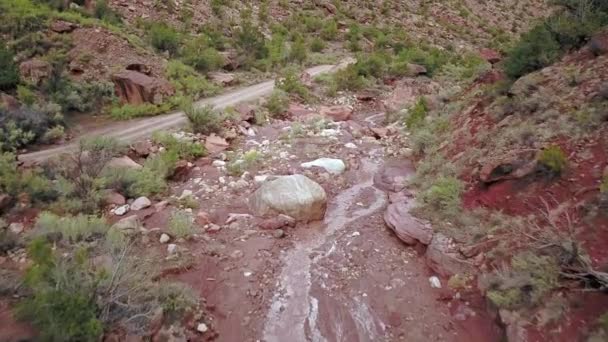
[19,62,340,162]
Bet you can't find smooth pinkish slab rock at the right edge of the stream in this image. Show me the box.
[384,201,433,245]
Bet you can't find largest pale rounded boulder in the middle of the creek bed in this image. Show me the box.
[249,174,327,221]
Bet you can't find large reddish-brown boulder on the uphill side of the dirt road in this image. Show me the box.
[112,70,175,105]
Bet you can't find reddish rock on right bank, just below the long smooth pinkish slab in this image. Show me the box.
[426,233,474,277]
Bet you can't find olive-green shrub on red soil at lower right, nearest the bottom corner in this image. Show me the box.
[487,252,560,309]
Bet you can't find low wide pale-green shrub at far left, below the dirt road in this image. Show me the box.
[36,212,109,242]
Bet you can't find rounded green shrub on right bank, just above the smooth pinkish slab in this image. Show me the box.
[421,177,464,214]
